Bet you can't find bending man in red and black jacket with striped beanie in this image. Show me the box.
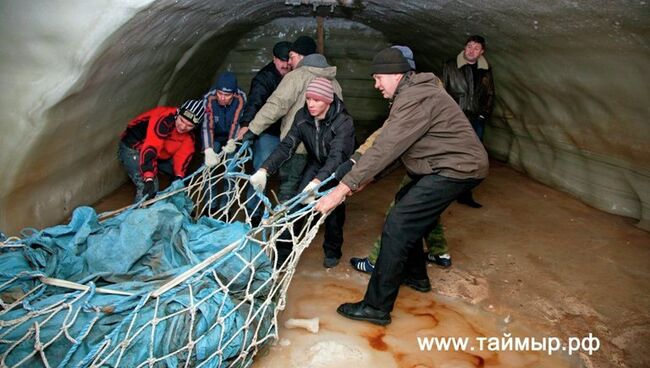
[118,100,204,202]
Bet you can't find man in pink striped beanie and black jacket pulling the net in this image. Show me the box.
[250,77,354,268]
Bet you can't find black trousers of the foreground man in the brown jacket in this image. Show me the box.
[364,174,481,312]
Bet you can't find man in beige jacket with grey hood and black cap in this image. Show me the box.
[240,36,343,202]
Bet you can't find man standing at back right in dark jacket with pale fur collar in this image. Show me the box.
[442,35,494,208]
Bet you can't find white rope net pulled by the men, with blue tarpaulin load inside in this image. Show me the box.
[0,143,325,368]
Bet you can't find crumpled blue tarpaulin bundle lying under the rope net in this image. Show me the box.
[0,188,274,367]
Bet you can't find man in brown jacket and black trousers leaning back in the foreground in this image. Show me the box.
[315,48,488,325]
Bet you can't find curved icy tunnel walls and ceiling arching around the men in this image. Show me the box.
[0,0,650,233]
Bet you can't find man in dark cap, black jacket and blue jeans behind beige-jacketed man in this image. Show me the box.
[239,41,291,221]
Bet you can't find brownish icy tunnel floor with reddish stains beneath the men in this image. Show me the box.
[96,161,650,367]
